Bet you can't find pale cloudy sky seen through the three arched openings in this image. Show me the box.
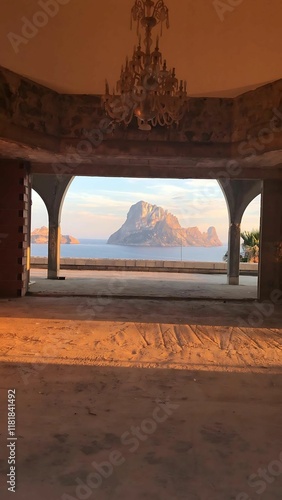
[32,177,260,243]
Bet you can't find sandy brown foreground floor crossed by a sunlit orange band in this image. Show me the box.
[0,297,282,500]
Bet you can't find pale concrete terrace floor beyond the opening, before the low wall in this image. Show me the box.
[29,269,257,300]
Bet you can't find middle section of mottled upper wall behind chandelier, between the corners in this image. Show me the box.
[60,95,233,143]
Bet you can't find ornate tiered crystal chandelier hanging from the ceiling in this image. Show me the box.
[102,0,188,130]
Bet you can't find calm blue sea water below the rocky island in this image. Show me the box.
[31,239,227,262]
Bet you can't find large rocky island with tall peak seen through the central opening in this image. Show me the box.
[108,201,222,247]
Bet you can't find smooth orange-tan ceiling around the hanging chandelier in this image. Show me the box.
[0,0,282,97]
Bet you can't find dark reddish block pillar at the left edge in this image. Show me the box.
[0,160,30,297]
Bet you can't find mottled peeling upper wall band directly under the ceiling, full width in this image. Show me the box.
[0,67,282,149]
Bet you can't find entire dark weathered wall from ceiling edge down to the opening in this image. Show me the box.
[0,67,282,179]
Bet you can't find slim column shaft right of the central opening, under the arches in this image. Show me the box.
[227,222,241,285]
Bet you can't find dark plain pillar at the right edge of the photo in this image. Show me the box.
[259,180,282,300]
